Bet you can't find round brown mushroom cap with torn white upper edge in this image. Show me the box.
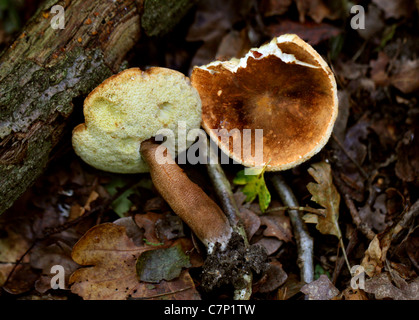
[191,34,338,171]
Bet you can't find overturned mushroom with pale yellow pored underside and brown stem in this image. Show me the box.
[72,67,232,252]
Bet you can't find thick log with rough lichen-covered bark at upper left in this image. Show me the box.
[0,0,196,214]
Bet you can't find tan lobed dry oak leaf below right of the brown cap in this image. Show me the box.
[303,162,342,239]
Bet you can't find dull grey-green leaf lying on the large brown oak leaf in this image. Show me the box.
[136,244,191,283]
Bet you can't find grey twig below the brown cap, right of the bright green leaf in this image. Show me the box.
[270,173,314,283]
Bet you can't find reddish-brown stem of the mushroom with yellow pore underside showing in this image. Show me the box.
[140,140,232,253]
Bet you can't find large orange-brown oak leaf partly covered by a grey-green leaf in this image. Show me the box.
[70,223,200,300]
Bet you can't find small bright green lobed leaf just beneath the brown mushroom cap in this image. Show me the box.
[233,168,271,212]
